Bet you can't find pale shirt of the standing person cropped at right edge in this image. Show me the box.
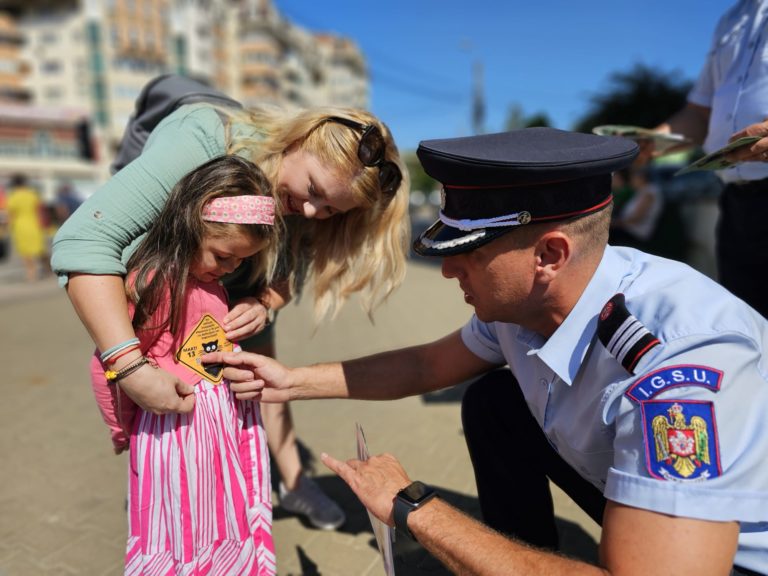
[688,0,768,182]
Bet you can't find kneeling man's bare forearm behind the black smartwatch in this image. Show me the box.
[408,498,607,576]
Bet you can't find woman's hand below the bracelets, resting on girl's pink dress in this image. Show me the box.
[119,364,195,414]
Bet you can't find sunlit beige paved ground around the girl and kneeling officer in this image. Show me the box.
[0,261,599,576]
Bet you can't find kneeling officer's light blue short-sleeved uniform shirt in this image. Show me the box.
[462,247,768,573]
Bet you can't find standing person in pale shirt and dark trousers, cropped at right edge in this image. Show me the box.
[656,0,768,316]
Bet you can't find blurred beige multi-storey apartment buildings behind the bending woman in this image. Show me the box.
[0,0,369,194]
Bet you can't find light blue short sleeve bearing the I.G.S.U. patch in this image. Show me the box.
[605,333,768,532]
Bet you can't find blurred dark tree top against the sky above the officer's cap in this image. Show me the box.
[574,63,691,132]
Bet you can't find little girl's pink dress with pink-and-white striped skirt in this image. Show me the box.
[96,279,275,576]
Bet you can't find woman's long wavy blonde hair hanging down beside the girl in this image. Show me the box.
[226,107,410,320]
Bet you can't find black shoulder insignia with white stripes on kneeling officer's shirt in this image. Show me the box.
[597,294,659,374]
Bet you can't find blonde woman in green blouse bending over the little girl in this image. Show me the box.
[52,103,409,529]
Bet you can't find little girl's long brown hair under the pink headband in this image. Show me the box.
[126,155,279,336]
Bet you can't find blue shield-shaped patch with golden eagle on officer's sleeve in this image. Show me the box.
[641,400,722,482]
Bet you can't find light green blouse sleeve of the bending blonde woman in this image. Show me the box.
[51,104,226,286]
